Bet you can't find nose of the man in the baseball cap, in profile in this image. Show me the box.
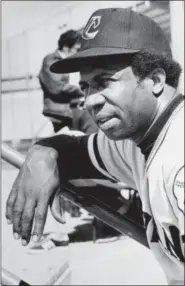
[84,92,105,110]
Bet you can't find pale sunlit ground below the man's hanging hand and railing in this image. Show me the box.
[1,168,167,285]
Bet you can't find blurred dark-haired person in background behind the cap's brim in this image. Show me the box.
[39,30,84,132]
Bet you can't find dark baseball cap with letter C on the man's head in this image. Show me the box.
[50,8,172,73]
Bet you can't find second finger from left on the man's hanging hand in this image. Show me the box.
[12,194,25,239]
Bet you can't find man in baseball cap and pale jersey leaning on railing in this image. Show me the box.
[6,8,185,285]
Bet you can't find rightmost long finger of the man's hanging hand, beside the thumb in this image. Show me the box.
[33,200,48,242]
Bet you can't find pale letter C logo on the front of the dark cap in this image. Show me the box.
[82,16,101,40]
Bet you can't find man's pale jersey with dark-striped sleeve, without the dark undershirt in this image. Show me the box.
[88,99,185,285]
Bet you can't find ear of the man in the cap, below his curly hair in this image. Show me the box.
[148,68,166,97]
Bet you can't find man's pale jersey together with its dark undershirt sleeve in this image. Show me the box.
[37,96,185,285]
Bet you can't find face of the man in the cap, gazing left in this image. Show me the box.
[80,64,157,140]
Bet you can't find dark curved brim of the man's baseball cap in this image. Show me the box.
[50,48,140,73]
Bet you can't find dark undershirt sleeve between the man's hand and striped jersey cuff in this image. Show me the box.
[35,134,106,182]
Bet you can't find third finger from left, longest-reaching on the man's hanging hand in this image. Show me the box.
[21,198,36,245]
